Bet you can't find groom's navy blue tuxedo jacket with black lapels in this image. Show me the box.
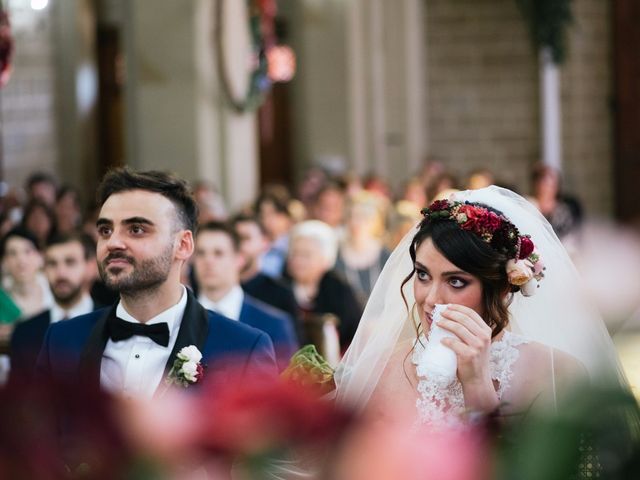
[36,290,277,388]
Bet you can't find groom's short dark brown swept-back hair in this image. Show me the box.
[97,167,198,232]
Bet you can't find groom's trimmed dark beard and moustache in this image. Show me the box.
[98,244,173,295]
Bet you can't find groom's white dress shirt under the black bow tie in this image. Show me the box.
[100,286,187,399]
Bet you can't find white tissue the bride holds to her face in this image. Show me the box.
[417,305,458,387]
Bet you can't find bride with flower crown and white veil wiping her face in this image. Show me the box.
[336,187,624,425]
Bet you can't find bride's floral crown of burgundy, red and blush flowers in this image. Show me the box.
[421,200,544,297]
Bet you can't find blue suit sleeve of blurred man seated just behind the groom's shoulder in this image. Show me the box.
[238,294,299,371]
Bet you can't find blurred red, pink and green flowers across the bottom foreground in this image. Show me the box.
[0,344,640,480]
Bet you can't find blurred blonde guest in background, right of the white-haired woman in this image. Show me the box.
[336,192,389,303]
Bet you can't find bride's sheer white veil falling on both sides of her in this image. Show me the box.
[335,186,625,409]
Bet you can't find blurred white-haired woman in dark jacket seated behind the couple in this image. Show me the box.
[287,220,362,351]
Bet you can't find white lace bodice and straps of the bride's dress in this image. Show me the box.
[411,330,528,425]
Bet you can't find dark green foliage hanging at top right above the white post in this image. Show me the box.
[516,0,573,64]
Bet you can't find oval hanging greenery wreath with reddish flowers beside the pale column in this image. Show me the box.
[214,0,271,113]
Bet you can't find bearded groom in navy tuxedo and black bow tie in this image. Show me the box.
[38,168,277,398]
